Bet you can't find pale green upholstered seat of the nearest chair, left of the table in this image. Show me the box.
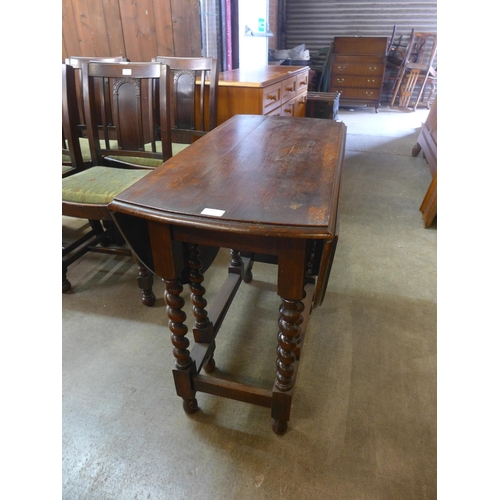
[62,167,150,205]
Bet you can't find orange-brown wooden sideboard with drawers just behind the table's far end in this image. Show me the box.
[218,66,309,125]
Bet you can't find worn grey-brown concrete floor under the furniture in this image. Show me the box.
[62,108,437,500]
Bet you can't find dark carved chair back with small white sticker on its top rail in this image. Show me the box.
[83,62,172,169]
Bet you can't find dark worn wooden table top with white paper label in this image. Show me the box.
[110,115,346,239]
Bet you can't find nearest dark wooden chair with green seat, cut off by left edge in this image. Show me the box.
[62,63,156,306]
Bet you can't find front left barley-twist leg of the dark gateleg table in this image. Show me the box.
[164,280,198,413]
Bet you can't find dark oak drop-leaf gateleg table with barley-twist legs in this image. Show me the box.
[110,115,346,434]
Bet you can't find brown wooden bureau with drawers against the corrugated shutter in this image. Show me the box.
[329,36,387,113]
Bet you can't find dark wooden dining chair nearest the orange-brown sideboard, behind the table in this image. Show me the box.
[153,56,219,146]
